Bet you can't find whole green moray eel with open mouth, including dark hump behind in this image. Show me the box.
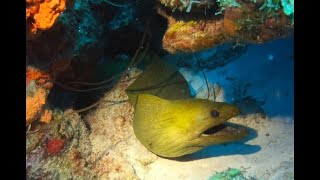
[126,53,247,157]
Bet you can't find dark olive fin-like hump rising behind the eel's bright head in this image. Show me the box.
[126,52,191,104]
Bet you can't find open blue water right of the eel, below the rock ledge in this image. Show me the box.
[206,37,294,120]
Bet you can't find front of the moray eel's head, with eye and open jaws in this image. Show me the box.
[190,100,247,147]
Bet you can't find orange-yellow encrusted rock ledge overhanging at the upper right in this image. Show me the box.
[157,0,293,54]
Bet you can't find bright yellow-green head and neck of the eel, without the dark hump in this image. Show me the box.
[133,94,247,157]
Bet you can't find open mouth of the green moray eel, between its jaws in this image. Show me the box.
[201,122,246,136]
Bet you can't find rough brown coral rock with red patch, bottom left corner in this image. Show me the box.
[26,110,92,179]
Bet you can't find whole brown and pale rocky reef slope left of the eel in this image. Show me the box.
[27,70,157,179]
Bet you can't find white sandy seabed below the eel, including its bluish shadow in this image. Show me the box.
[145,115,294,180]
